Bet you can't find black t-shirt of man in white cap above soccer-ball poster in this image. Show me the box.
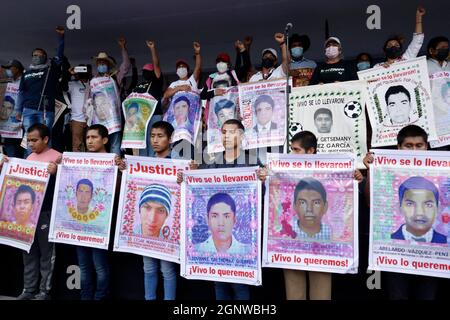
[310,60,358,84]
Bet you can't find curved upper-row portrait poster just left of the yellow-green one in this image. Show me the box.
[86,77,122,134]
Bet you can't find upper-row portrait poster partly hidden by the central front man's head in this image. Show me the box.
[207,87,240,153]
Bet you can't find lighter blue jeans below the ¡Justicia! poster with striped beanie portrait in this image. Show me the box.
[143,257,177,300]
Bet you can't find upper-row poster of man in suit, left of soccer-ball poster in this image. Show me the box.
[238,80,286,149]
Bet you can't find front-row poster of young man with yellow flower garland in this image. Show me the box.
[48,152,117,250]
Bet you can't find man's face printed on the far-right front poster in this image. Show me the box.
[400,189,438,236]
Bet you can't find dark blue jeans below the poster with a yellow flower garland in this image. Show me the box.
[77,247,109,300]
